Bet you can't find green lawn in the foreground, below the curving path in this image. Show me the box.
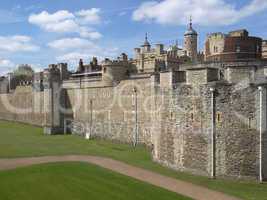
[0,163,190,200]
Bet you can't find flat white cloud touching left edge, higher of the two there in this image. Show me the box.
[0,35,39,52]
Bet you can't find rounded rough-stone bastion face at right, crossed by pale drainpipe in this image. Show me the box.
[153,84,266,178]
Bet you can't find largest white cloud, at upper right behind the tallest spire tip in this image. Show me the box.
[132,0,267,25]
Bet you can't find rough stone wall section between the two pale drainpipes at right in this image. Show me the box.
[216,85,259,177]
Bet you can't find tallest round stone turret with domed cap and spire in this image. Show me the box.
[184,18,198,62]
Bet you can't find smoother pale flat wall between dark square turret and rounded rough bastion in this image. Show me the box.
[63,78,155,145]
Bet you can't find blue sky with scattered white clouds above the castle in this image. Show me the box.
[0,0,267,74]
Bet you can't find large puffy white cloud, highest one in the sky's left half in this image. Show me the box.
[28,8,102,39]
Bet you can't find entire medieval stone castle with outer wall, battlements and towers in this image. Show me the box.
[0,22,267,181]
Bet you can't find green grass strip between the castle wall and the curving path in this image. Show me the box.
[0,122,267,200]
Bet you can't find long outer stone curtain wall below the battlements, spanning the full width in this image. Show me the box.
[0,70,267,181]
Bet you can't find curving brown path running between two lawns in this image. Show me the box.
[0,155,241,200]
